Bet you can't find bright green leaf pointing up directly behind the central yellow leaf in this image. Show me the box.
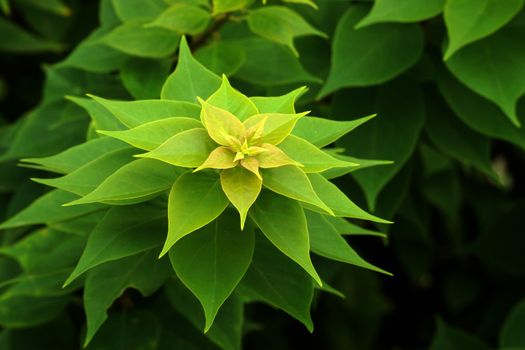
[206,75,259,121]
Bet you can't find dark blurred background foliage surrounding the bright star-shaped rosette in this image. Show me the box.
[0,0,525,350]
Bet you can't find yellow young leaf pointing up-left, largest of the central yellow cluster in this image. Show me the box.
[199,99,245,146]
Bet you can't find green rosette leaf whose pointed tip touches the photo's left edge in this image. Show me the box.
[0,190,102,229]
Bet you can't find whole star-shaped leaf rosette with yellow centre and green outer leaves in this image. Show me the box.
[2,38,387,344]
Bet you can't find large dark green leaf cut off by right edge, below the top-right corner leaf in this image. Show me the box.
[446,28,525,126]
